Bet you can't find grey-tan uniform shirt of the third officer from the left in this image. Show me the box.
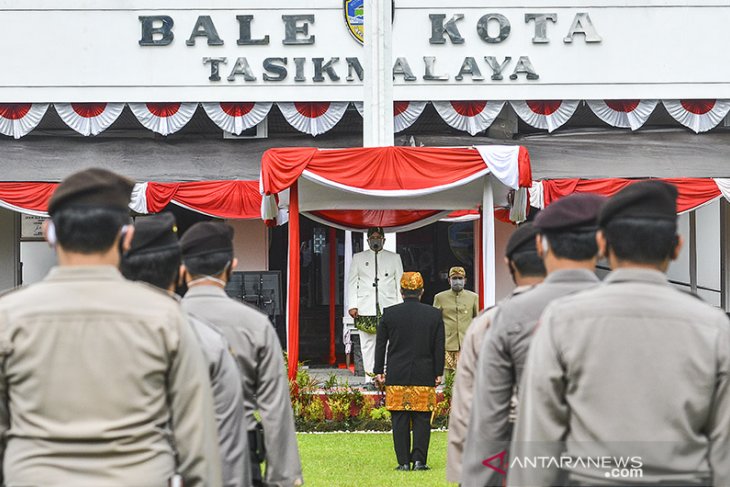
[182,285,302,486]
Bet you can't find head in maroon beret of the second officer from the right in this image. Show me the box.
[534,193,606,261]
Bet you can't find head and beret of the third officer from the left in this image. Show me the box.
[180,222,233,276]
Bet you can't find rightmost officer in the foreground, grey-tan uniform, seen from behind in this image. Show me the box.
[507,181,730,486]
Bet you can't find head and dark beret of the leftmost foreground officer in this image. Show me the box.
[48,168,134,254]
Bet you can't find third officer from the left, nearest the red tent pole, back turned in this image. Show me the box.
[180,222,303,487]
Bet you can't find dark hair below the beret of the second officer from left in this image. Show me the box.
[121,247,182,289]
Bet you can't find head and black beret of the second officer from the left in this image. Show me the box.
[121,213,181,289]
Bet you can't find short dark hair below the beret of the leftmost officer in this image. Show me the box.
[51,206,130,254]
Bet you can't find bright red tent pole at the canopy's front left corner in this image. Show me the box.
[286,182,300,380]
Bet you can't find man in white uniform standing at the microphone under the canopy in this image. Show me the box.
[347,227,403,384]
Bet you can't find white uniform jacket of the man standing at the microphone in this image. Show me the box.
[347,249,403,316]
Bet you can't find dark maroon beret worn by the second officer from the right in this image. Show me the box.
[534,193,606,232]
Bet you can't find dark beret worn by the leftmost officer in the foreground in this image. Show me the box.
[48,168,134,215]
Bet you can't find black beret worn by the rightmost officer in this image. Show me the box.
[598,180,677,227]
